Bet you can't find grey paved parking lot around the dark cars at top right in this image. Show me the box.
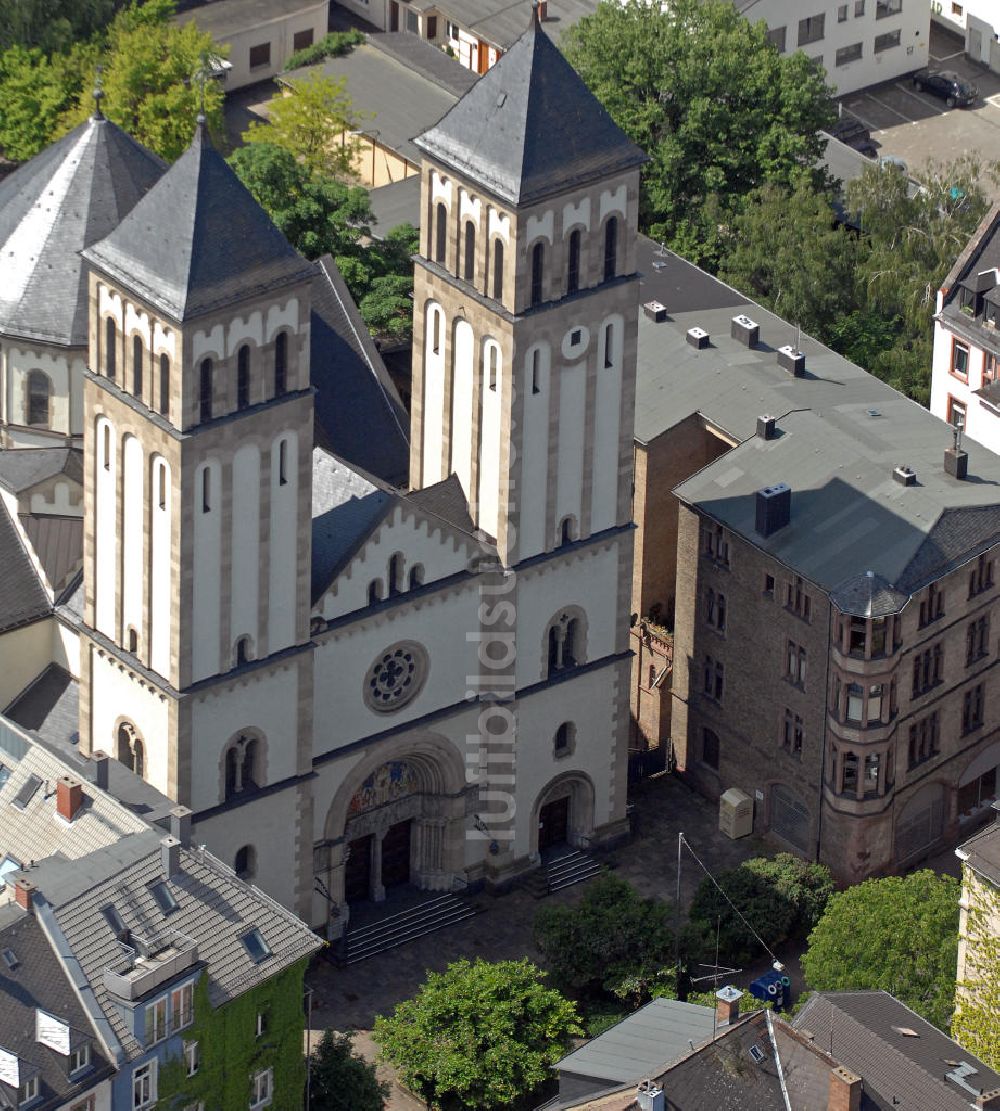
[842,26,1000,199]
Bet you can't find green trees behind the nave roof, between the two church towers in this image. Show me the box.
[229,142,419,340]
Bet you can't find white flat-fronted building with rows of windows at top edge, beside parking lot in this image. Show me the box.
[737,0,930,96]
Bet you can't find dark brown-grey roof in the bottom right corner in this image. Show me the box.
[792,991,1000,1111]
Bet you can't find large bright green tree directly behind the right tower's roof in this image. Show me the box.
[563,0,836,253]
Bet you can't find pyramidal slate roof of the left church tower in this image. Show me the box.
[83,123,312,322]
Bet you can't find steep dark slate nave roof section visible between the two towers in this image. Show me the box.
[310,262,410,486]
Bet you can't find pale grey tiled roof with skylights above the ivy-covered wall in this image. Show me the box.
[37,830,322,1058]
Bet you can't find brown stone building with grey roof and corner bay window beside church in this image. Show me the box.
[632,241,1000,882]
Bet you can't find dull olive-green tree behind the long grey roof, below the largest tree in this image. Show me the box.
[719,182,858,342]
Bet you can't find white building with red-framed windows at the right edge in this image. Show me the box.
[931,204,1000,452]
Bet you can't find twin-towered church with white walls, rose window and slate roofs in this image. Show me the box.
[0,6,643,937]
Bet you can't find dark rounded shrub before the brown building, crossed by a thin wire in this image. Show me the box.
[684,852,833,964]
